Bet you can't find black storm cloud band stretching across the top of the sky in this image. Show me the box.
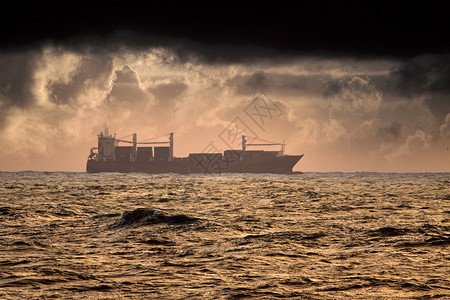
[4,0,450,62]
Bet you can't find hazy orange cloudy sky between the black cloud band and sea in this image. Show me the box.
[0,46,450,172]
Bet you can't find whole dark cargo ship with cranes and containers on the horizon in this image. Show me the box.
[86,126,303,174]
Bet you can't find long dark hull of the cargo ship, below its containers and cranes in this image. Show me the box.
[86,155,303,174]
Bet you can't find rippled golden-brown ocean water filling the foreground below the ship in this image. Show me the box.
[0,172,450,299]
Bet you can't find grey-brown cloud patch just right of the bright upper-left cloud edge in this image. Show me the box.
[48,54,113,104]
